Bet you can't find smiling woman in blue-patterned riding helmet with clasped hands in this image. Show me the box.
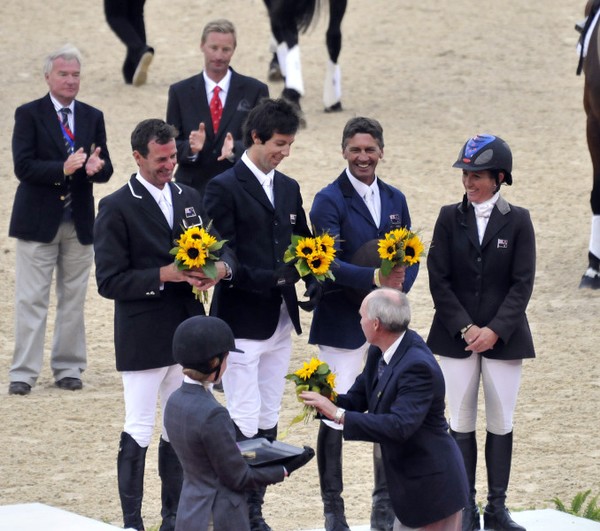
[427,135,535,531]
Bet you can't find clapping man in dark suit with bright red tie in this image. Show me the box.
[167,19,269,198]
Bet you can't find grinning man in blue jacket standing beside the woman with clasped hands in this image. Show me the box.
[309,117,419,531]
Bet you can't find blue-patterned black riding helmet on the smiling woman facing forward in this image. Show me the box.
[452,135,512,185]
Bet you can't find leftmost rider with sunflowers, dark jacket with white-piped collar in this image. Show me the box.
[94,119,235,531]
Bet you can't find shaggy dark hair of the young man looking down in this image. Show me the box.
[243,98,300,148]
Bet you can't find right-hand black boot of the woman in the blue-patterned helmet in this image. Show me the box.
[483,431,525,531]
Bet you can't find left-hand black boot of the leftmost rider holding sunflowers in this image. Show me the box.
[117,432,148,531]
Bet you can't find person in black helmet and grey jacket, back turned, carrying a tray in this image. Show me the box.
[165,316,314,531]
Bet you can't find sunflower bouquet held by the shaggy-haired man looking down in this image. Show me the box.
[283,232,335,282]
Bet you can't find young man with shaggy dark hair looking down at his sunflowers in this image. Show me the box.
[204,99,319,531]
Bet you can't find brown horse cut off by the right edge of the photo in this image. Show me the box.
[577,0,600,289]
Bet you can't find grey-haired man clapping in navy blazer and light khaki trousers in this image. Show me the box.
[8,45,113,395]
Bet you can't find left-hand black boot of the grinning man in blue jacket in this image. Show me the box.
[317,422,350,531]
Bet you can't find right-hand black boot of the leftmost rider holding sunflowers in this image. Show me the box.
[158,437,183,531]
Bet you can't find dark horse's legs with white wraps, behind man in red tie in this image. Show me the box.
[264,0,347,118]
